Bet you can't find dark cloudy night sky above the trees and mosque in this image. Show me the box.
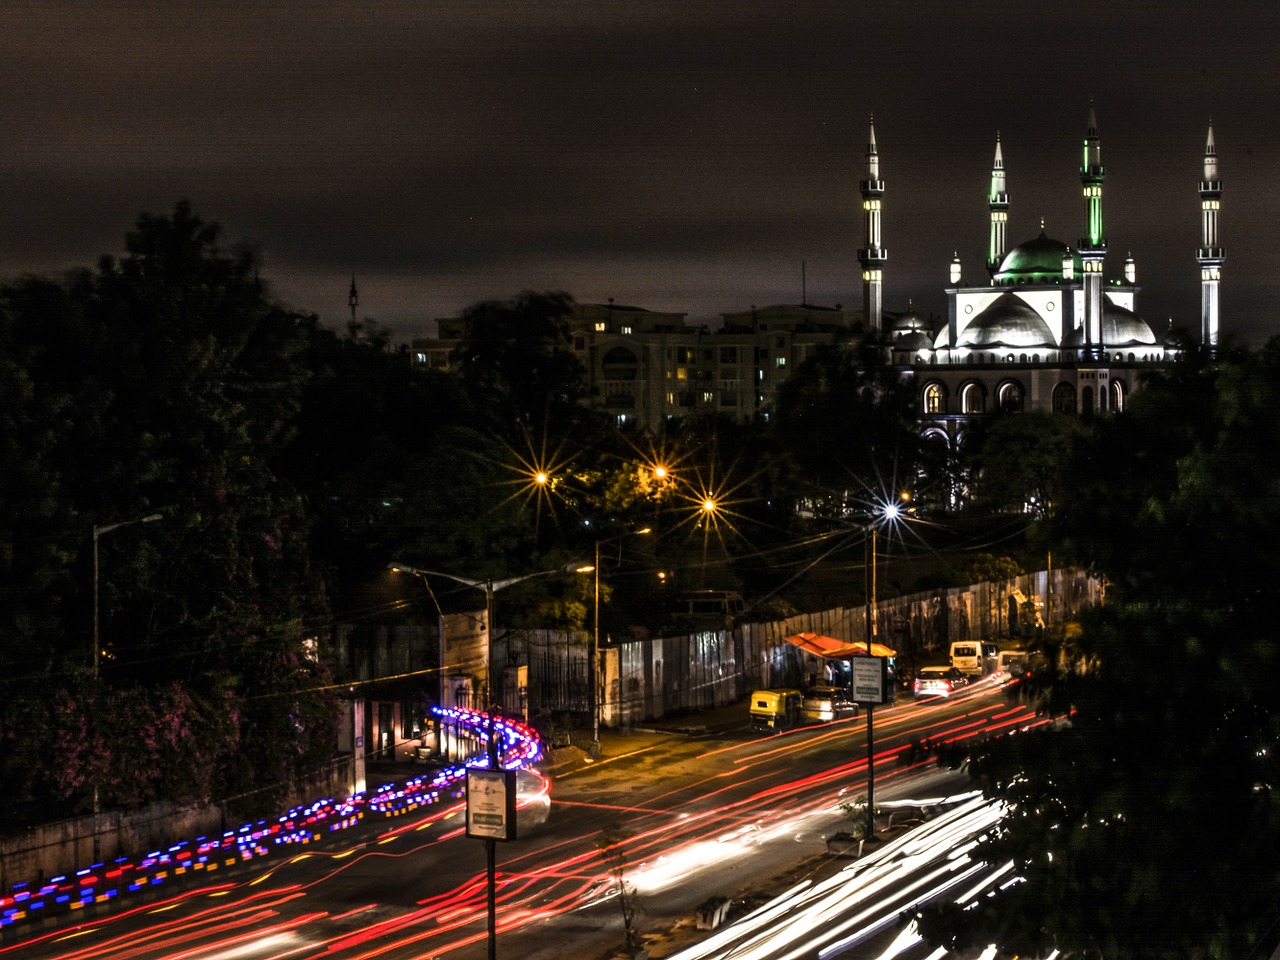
[0,0,1280,343]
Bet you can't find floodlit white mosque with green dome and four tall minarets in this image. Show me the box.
[875,106,1222,447]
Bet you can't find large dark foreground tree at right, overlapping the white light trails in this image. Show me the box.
[922,342,1280,960]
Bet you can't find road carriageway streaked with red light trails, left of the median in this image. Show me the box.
[0,686,1033,960]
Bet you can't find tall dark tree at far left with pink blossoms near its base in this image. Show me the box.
[0,204,333,818]
